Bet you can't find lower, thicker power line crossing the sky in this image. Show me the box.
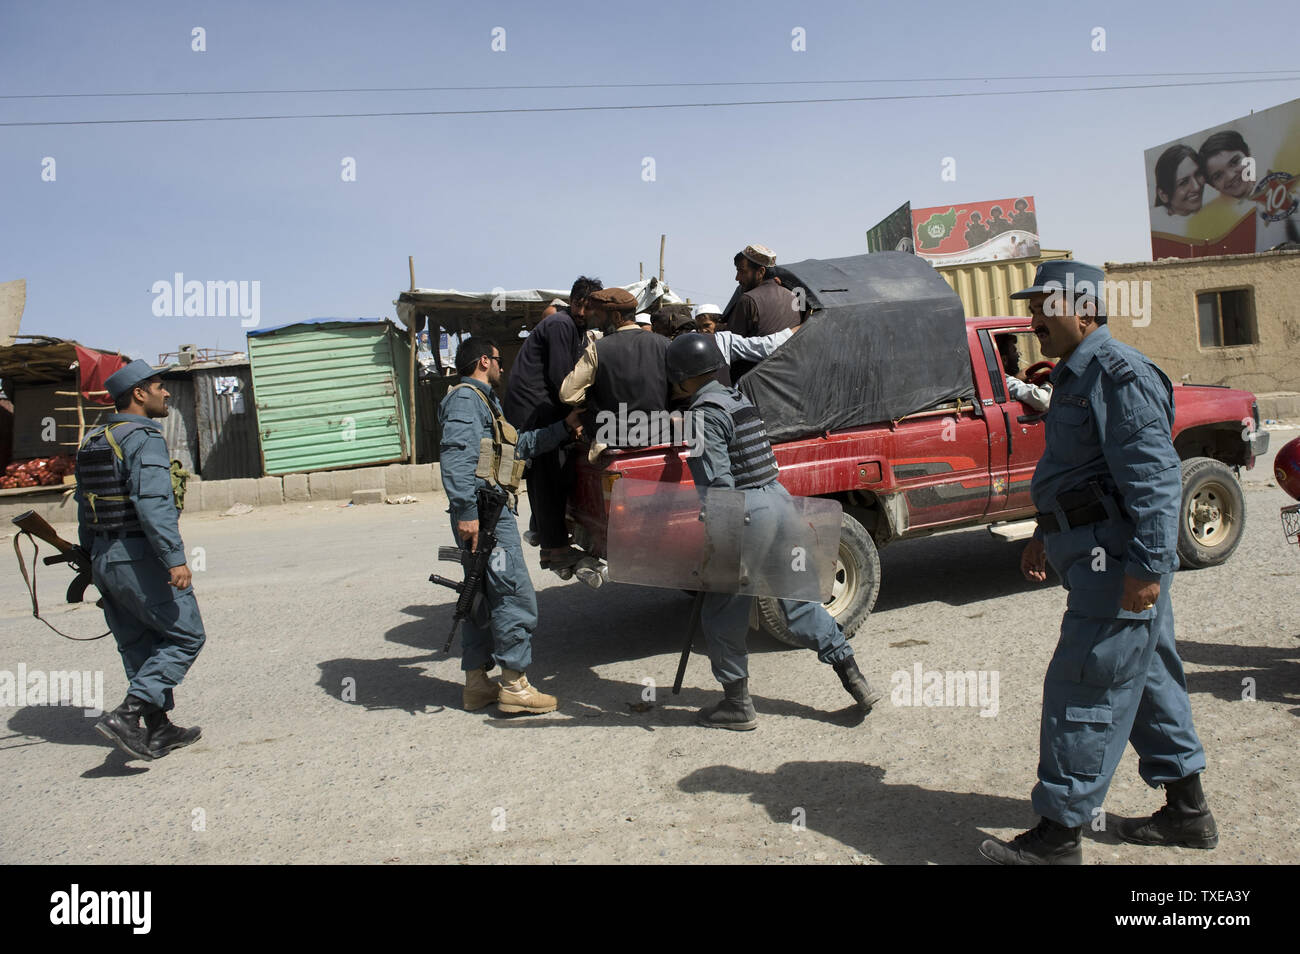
[0,75,1300,127]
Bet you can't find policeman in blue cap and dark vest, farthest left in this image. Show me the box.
[77,360,205,759]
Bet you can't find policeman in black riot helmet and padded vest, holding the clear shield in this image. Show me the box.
[668,333,880,730]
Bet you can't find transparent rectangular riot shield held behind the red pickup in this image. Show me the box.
[607,477,840,603]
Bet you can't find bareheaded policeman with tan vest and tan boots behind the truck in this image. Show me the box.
[438,338,581,714]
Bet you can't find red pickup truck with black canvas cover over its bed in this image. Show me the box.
[568,252,1268,642]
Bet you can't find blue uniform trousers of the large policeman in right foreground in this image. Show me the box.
[1032,573,1205,828]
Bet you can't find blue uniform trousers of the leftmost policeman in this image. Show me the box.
[91,539,207,711]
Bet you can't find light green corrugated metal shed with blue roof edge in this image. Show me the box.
[248,318,411,477]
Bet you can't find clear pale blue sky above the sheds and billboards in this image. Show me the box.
[0,0,1300,359]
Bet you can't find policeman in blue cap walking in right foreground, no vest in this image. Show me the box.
[980,261,1218,864]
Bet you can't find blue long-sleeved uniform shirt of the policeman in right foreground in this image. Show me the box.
[1031,325,1182,582]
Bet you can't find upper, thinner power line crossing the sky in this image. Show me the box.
[0,69,1295,100]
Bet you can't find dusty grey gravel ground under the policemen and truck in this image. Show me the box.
[0,430,1300,864]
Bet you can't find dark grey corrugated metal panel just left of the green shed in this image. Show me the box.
[190,365,261,481]
